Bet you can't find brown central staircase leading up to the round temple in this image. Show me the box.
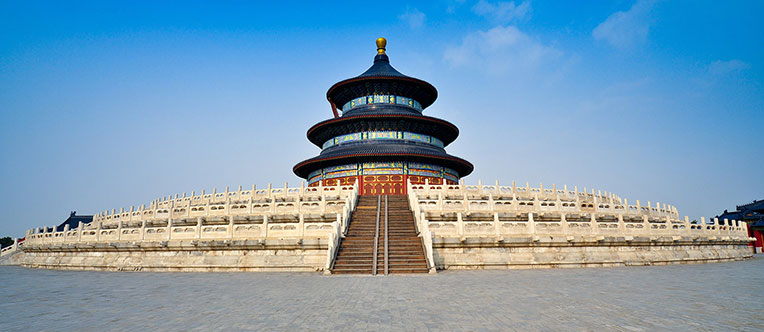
[332,195,429,274]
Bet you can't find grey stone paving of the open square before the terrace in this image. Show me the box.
[0,255,764,331]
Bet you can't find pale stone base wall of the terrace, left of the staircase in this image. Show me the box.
[5,238,328,272]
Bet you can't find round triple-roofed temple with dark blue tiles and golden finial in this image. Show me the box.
[293,38,473,195]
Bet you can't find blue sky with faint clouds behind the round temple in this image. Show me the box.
[0,1,764,236]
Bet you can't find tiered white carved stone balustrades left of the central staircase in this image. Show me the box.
[26,180,358,245]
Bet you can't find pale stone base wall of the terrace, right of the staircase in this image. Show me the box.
[432,237,753,270]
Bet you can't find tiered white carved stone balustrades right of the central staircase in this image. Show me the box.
[408,183,749,241]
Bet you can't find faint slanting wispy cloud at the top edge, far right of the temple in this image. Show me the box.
[592,0,654,48]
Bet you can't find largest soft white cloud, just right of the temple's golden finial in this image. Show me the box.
[443,26,562,74]
